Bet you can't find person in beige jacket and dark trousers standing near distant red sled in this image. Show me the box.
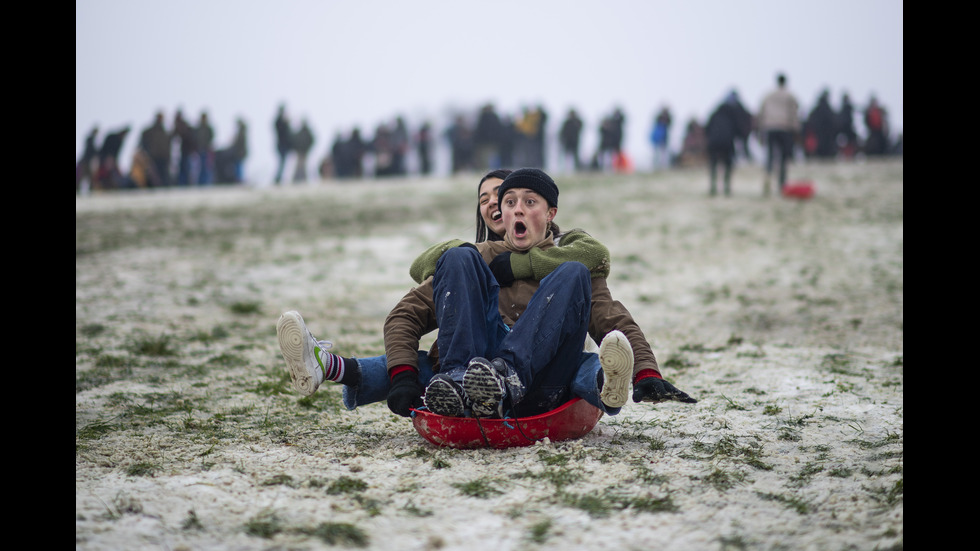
[757,73,800,195]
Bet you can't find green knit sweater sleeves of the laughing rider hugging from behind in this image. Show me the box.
[408,229,610,283]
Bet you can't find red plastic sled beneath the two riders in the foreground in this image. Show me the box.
[412,398,602,449]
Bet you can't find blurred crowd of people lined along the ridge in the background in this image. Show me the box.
[75,77,902,193]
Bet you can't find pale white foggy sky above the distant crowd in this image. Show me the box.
[75,0,904,181]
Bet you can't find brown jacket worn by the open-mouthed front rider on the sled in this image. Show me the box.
[384,233,660,375]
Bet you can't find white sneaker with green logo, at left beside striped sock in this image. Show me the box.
[276,310,333,396]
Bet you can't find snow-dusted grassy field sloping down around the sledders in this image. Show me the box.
[75,159,904,551]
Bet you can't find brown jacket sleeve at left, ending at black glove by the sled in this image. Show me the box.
[384,277,437,369]
